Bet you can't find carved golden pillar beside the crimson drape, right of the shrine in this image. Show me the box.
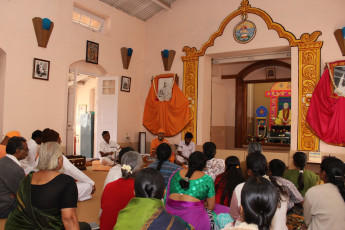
[297,39,323,151]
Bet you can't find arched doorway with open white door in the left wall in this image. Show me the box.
[66,60,119,158]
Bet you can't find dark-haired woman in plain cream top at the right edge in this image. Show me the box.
[303,157,345,230]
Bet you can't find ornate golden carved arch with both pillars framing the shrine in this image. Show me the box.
[182,0,323,151]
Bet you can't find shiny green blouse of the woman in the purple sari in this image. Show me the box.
[170,171,216,200]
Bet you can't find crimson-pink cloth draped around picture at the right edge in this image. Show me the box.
[307,66,345,146]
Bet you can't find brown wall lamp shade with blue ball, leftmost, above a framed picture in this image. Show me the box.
[32,17,54,48]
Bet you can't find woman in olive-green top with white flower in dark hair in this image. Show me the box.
[284,152,320,197]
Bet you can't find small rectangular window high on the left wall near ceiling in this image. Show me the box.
[72,7,105,32]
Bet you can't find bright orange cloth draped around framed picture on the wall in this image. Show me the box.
[143,74,190,137]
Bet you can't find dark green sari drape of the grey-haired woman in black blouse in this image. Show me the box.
[5,173,64,230]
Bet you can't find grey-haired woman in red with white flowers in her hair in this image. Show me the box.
[100,151,143,230]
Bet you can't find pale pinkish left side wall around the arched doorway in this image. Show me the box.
[0,0,145,147]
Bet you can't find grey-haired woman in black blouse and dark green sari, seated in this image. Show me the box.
[5,142,91,230]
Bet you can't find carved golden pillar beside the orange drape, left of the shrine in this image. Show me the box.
[182,47,199,142]
